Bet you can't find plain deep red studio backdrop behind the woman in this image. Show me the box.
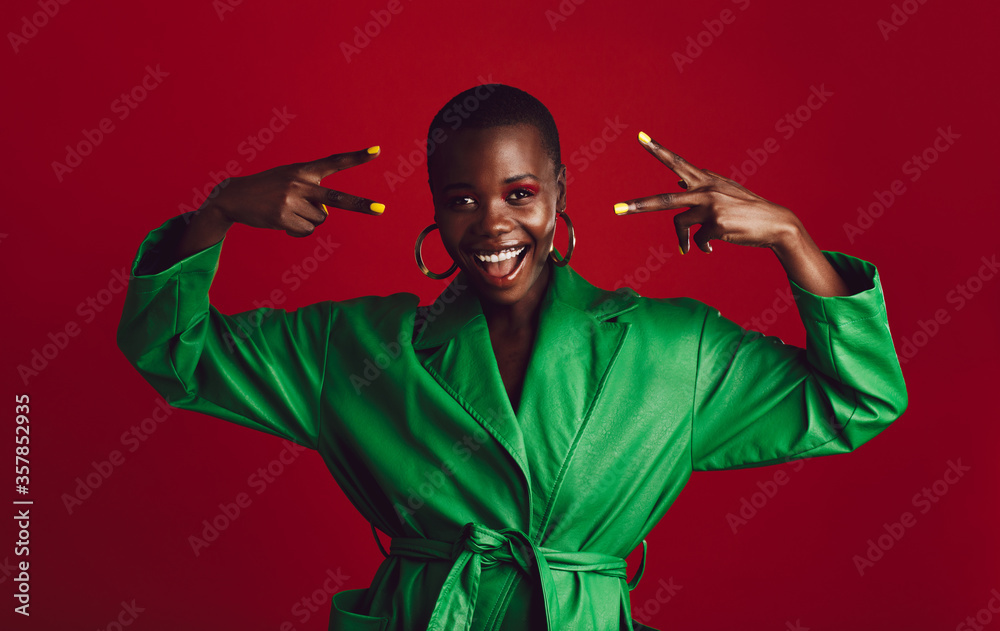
[0,0,1000,630]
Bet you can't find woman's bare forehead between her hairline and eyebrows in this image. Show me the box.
[431,125,552,186]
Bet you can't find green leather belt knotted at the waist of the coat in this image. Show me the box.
[389,522,646,631]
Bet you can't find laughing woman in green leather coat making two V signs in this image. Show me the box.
[118,85,907,630]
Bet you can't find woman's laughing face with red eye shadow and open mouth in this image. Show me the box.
[431,125,566,304]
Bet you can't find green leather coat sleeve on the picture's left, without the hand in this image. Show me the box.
[117,215,332,449]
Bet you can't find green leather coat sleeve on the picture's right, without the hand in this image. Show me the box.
[691,252,907,471]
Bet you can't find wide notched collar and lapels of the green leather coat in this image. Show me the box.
[413,263,639,537]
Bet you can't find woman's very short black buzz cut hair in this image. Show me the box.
[427,83,562,184]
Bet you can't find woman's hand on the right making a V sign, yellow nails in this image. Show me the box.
[615,132,803,254]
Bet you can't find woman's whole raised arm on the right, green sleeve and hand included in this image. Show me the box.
[615,133,907,470]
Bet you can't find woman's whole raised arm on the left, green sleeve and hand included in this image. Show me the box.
[117,150,378,448]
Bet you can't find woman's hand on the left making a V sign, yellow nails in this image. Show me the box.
[205,146,385,237]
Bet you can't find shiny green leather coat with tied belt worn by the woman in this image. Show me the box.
[118,217,907,631]
